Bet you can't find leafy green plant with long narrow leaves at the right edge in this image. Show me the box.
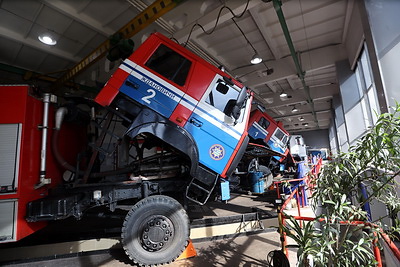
[284,104,400,267]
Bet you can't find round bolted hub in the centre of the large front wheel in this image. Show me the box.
[141,215,174,251]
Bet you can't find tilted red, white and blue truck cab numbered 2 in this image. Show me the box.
[95,33,251,204]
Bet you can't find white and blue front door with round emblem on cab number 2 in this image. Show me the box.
[185,74,246,174]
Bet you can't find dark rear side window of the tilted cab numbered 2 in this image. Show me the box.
[145,44,192,86]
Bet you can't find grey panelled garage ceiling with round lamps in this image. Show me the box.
[0,0,354,132]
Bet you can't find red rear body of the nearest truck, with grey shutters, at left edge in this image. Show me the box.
[0,85,83,243]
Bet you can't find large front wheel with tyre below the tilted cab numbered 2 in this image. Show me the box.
[121,195,190,266]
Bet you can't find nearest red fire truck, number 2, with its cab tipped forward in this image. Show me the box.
[0,33,252,265]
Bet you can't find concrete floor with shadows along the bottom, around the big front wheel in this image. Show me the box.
[4,231,296,267]
